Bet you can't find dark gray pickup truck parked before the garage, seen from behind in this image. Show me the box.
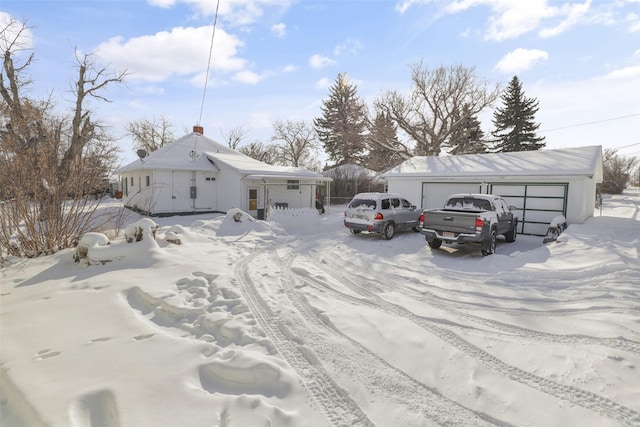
[418,194,518,255]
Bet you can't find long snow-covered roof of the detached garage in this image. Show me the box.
[382,145,602,182]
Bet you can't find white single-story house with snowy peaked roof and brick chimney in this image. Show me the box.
[116,126,330,219]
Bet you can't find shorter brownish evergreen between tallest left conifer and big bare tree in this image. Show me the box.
[363,111,406,172]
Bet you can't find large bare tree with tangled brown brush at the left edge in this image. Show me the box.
[0,21,126,256]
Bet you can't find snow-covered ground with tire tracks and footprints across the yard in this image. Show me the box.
[0,189,640,427]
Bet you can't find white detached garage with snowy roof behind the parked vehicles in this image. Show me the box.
[382,146,602,235]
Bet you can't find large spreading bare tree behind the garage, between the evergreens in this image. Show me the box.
[375,61,499,156]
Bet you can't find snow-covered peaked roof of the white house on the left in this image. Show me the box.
[115,132,322,179]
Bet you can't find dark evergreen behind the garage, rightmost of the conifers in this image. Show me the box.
[491,76,545,152]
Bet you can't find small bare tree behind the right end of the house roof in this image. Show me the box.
[271,120,320,170]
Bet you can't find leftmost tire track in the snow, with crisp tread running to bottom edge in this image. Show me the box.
[234,251,374,427]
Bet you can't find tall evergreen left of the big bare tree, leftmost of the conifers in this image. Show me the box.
[313,74,367,165]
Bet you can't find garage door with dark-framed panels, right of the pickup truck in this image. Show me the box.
[489,183,569,236]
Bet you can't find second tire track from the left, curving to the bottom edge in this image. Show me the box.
[270,251,498,426]
